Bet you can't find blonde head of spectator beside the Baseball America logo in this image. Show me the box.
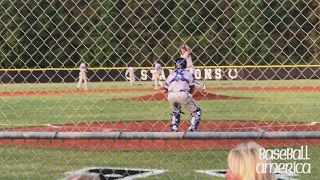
[225,142,275,180]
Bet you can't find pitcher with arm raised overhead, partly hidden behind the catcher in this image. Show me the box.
[180,44,206,91]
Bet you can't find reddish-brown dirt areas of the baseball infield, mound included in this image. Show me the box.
[0,87,320,150]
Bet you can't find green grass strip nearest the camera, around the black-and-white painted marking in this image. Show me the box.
[0,146,320,180]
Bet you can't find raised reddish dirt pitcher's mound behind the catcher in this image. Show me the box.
[126,91,247,101]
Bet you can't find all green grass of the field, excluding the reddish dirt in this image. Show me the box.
[0,80,320,179]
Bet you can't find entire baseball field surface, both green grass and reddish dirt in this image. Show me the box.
[0,80,320,179]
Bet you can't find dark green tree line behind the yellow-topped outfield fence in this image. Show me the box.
[0,0,320,68]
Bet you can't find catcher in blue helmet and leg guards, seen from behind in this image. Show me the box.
[162,58,202,132]
